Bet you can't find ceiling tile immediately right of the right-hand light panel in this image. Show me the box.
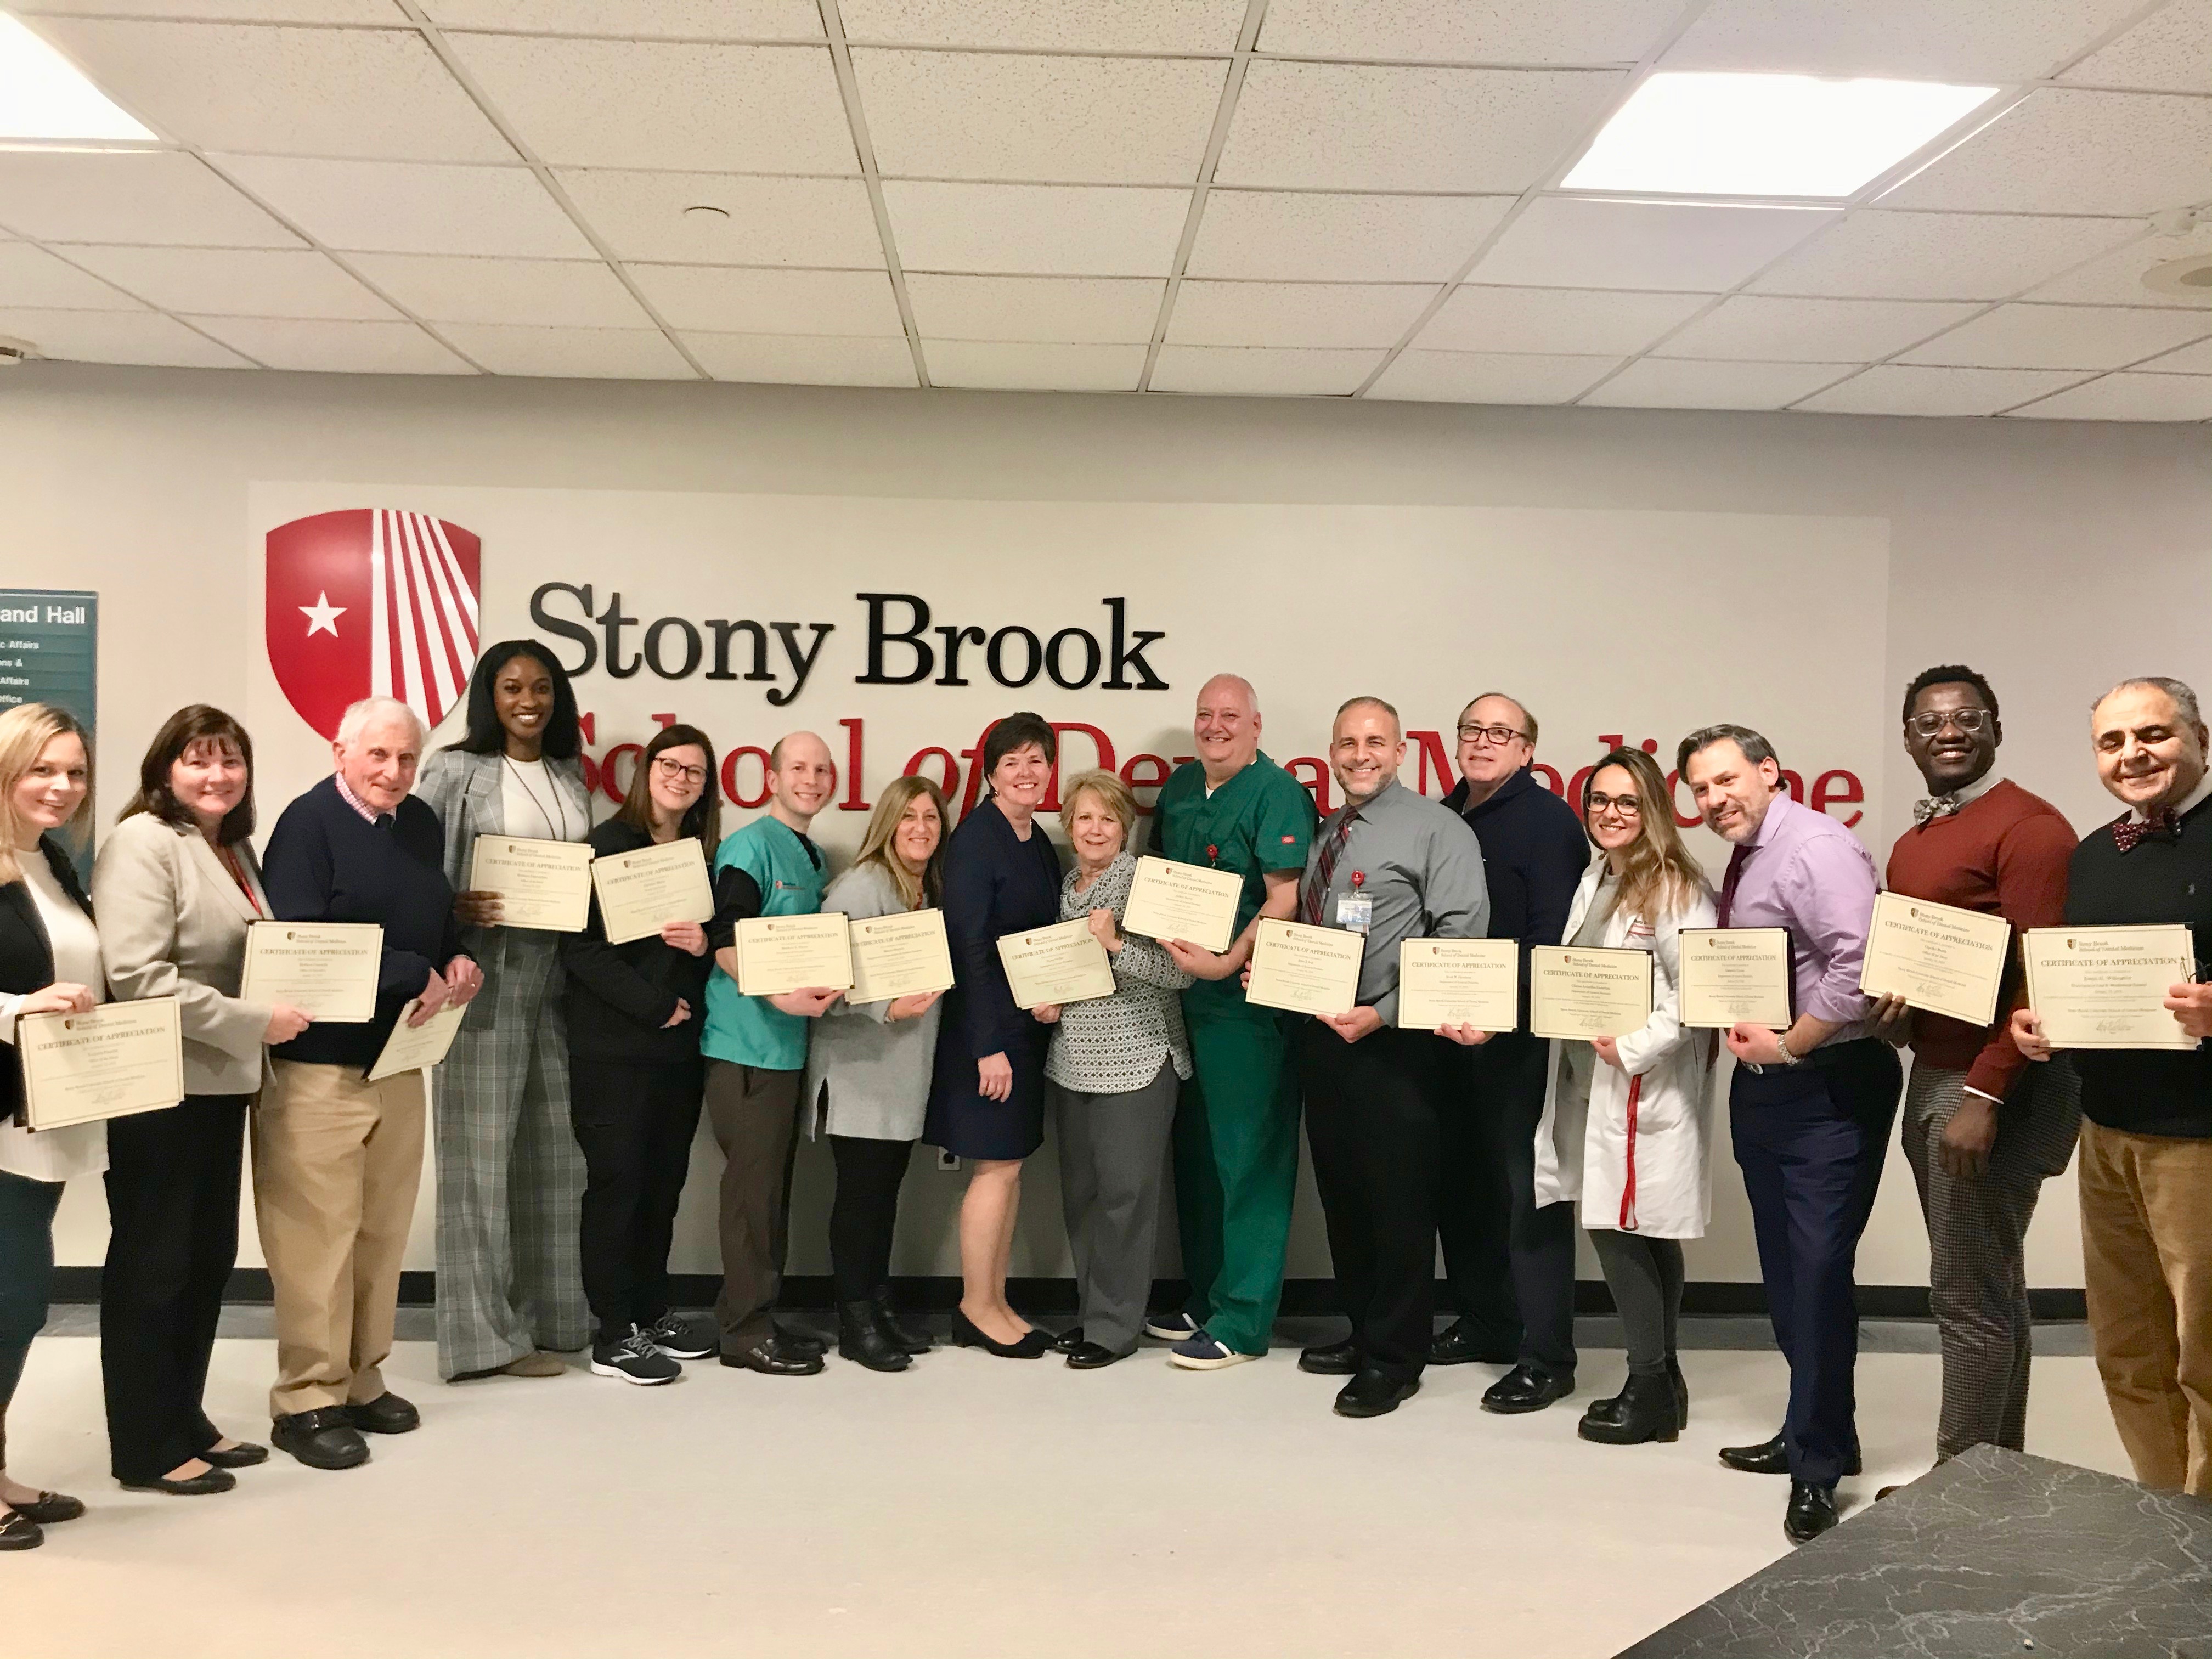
[1882,86,2212,215]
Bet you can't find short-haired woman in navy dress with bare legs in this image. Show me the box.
[922,714,1059,1361]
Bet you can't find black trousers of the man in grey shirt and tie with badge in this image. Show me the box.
[1294,1020,1447,1380]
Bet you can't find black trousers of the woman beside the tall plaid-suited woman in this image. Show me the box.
[568,1053,706,1340]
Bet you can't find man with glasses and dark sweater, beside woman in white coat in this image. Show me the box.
[1429,692,1590,1411]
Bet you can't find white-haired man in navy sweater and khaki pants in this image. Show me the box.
[252,697,482,1469]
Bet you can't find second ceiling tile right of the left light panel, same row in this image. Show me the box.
[447,36,860,172]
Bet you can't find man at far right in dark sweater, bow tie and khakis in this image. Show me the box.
[2013,679,2212,1498]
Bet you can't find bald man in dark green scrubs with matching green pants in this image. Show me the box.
[1146,675,1316,1372]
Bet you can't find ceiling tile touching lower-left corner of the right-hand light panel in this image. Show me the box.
[1190,190,1513,283]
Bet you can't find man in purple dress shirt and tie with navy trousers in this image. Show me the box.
[1677,725,1903,1544]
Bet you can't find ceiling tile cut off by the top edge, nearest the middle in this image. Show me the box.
[843,0,1245,53]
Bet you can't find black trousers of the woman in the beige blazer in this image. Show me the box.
[99,1095,248,1484]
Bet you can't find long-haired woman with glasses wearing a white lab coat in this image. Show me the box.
[1535,750,1714,1447]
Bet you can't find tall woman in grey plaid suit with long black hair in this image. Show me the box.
[416,639,591,1383]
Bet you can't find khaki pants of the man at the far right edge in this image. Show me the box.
[2081,1121,2212,1498]
